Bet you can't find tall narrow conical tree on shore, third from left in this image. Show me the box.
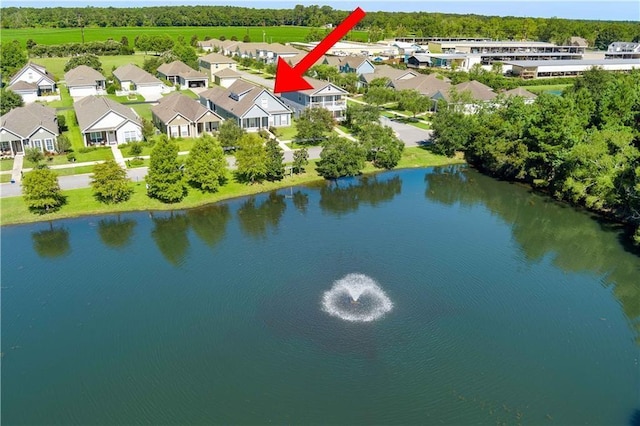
[146,135,187,203]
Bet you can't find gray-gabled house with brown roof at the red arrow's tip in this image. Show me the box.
[200,80,292,130]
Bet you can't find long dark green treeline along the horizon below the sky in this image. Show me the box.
[0,5,640,48]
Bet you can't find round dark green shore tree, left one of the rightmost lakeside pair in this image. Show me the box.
[316,135,366,179]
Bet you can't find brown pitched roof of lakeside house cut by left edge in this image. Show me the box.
[0,103,59,139]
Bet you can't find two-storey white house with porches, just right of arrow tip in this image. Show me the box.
[280,78,348,120]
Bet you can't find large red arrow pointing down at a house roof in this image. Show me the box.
[273,7,365,93]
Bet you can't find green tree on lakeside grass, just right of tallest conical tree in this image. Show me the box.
[185,134,227,192]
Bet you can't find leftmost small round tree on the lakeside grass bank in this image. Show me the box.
[22,168,65,214]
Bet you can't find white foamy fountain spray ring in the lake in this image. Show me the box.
[322,274,393,322]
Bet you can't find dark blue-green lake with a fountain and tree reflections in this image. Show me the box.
[1,167,640,425]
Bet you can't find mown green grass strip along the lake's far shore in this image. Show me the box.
[0,148,464,225]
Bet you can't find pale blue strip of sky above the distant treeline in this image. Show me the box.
[0,0,640,21]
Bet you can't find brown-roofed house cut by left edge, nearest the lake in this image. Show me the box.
[0,103,60,156]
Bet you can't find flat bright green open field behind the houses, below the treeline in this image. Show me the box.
[2,26,367,46]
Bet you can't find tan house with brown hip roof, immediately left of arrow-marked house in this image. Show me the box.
[151,92,222,138]
